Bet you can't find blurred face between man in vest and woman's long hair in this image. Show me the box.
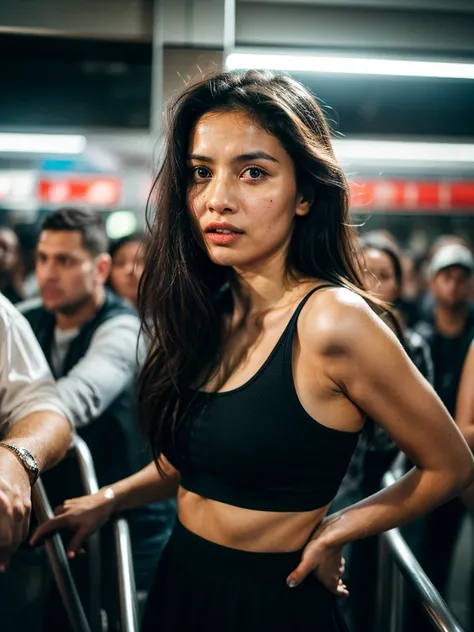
[110,241,145,304]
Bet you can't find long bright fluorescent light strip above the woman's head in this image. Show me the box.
[226,53,474,79]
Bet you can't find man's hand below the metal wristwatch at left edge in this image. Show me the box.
[0,450,31,571]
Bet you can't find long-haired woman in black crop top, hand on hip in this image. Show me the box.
[31,71,474,632]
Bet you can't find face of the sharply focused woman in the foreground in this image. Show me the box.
[187,111,310,272]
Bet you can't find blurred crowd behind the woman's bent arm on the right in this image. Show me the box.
[334,231,474,632]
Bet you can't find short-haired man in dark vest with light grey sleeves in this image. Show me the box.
[19,208,175,630]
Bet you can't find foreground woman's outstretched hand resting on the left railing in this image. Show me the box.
[31,490,114,559]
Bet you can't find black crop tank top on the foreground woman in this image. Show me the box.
[163,285,359,512]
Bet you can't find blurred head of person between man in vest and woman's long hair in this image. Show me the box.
[109,233,146,307]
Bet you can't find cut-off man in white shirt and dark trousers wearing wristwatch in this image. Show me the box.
[0,294,72,632]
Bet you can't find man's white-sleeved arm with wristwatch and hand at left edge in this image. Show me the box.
[0,294,71,572]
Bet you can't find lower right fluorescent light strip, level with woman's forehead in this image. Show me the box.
[333,139,474,163]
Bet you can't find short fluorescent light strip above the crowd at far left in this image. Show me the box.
[0,133,87,154]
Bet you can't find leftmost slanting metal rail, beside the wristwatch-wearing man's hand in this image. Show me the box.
[31,479,90,632]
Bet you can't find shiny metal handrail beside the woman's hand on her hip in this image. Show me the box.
[378,468,464,632]
